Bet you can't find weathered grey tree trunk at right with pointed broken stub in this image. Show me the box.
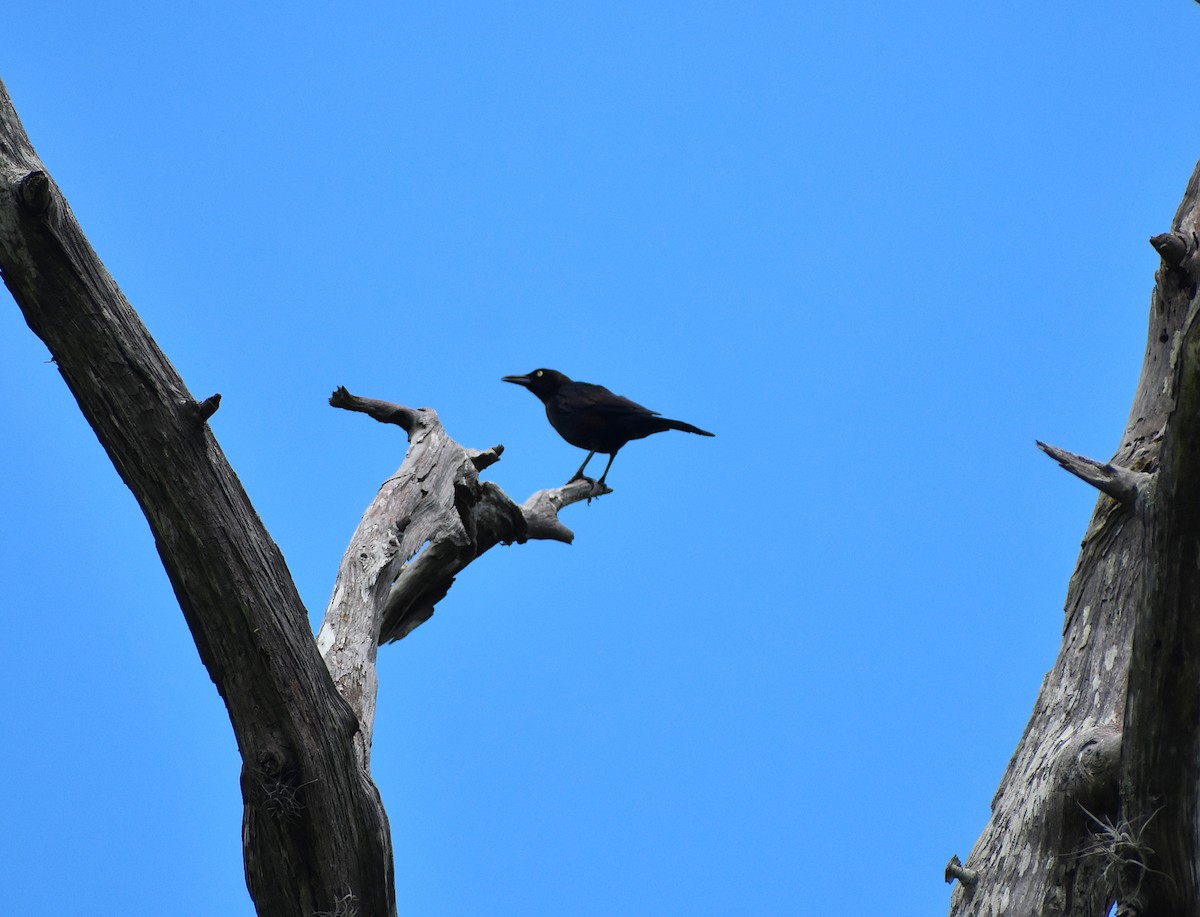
[946,166,1200,917]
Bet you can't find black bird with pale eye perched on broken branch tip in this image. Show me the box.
[502,370,713,486]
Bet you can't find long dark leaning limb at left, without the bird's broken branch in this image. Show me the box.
[0,76,395,917]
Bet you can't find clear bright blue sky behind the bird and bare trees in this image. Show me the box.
[0,0,1200,917]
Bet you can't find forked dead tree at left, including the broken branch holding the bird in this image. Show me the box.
[0,75,596,917]
